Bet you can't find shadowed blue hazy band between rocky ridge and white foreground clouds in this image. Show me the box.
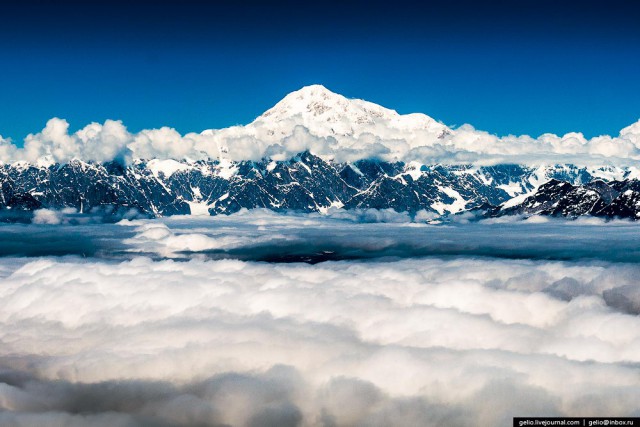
[0,209,640,263]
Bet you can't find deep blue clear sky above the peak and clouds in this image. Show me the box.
[0,0,640,143]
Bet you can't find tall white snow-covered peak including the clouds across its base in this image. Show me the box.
[202,85,454,161]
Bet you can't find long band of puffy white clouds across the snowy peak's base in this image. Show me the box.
[0,115,640,166]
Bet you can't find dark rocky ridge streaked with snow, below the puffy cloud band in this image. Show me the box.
[0,151,640,218]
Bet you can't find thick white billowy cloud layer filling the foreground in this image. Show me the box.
[0,258,640,426]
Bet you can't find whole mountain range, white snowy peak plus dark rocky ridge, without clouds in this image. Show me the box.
[0,85,640,220]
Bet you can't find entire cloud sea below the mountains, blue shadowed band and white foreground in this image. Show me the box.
[0,211,640,427]
